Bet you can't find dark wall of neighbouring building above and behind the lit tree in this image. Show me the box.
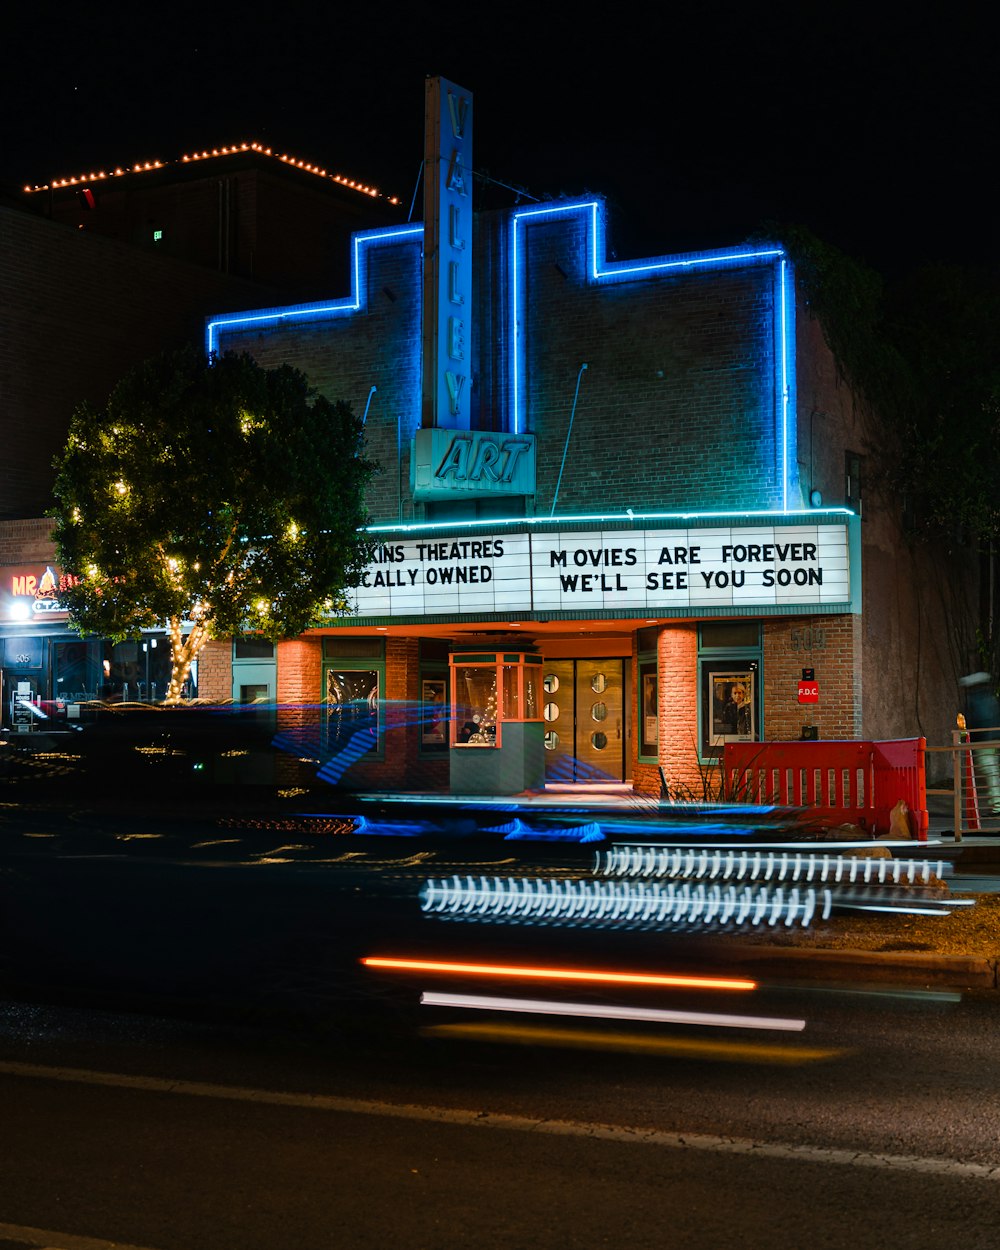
[0,209,273,518]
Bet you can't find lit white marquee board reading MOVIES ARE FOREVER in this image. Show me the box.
[353,524,851,618]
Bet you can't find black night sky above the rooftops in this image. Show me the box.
[0,0,1000,271]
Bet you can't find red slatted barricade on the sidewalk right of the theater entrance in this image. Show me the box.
[724,738,929,841]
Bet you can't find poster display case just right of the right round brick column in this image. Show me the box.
[698,621,761,760]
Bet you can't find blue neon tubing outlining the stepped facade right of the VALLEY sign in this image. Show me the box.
[509,200,795,515]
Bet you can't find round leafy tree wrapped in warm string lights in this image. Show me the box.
[50,349,376,703]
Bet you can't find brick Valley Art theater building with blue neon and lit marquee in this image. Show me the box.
[195,80,900,794]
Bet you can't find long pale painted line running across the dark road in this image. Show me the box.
[0,1061,1000,1180]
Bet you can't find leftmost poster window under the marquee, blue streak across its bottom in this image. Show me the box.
[323,636,385,763]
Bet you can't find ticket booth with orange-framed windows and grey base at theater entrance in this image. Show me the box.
[449,649,545,795]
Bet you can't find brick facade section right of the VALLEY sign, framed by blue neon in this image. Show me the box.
[512,215,780,513]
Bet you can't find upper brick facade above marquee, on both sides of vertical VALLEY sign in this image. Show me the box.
[211,215,781,520]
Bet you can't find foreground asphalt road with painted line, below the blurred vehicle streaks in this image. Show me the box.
[0,988,1000,1250]
